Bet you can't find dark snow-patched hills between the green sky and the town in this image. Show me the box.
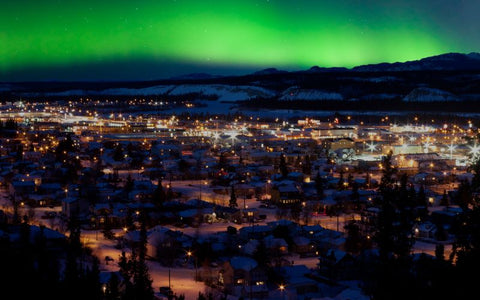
[0,53,480,111]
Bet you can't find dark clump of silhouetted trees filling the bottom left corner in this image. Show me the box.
[0,222,102,300]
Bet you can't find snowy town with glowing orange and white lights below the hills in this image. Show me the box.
[0,99,480,300]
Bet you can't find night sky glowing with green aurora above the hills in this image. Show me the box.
[0,0,480,81]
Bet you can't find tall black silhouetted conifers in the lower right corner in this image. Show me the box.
[361,154,480,299]
